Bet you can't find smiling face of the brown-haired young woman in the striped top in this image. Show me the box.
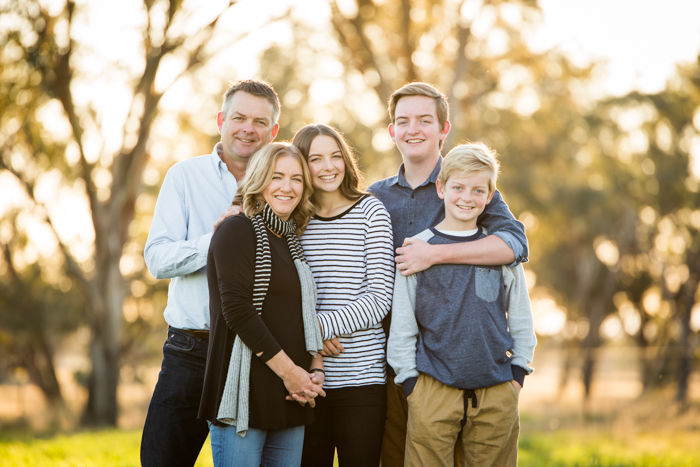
[308,135,345,193]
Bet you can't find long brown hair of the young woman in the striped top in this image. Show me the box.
[292,123,367,201]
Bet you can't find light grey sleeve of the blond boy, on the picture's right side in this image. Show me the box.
[502,264,537,374]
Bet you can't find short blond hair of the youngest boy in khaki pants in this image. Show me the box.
[438,142,501,196]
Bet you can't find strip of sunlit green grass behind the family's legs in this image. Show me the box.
[0,428,700,467]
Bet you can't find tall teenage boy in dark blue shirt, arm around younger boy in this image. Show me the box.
[369,83,528,467]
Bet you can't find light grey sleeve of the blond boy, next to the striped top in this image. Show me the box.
[387,270,418,384]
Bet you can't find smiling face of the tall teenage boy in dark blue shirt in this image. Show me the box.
[389,96,450,162]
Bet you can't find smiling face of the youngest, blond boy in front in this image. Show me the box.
[436,170,493,230]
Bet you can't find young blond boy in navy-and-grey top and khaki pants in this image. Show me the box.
[388,143,536,466]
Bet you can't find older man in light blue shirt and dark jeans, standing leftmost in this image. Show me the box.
[141,80,280,467]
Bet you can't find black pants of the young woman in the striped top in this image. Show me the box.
[301,384,386,467]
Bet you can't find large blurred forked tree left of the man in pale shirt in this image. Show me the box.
[0,0,238,425]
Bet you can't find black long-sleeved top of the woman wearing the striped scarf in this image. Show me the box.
[198,215,313,430]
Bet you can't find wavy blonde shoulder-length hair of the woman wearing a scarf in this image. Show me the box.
[233,143,314,235]
